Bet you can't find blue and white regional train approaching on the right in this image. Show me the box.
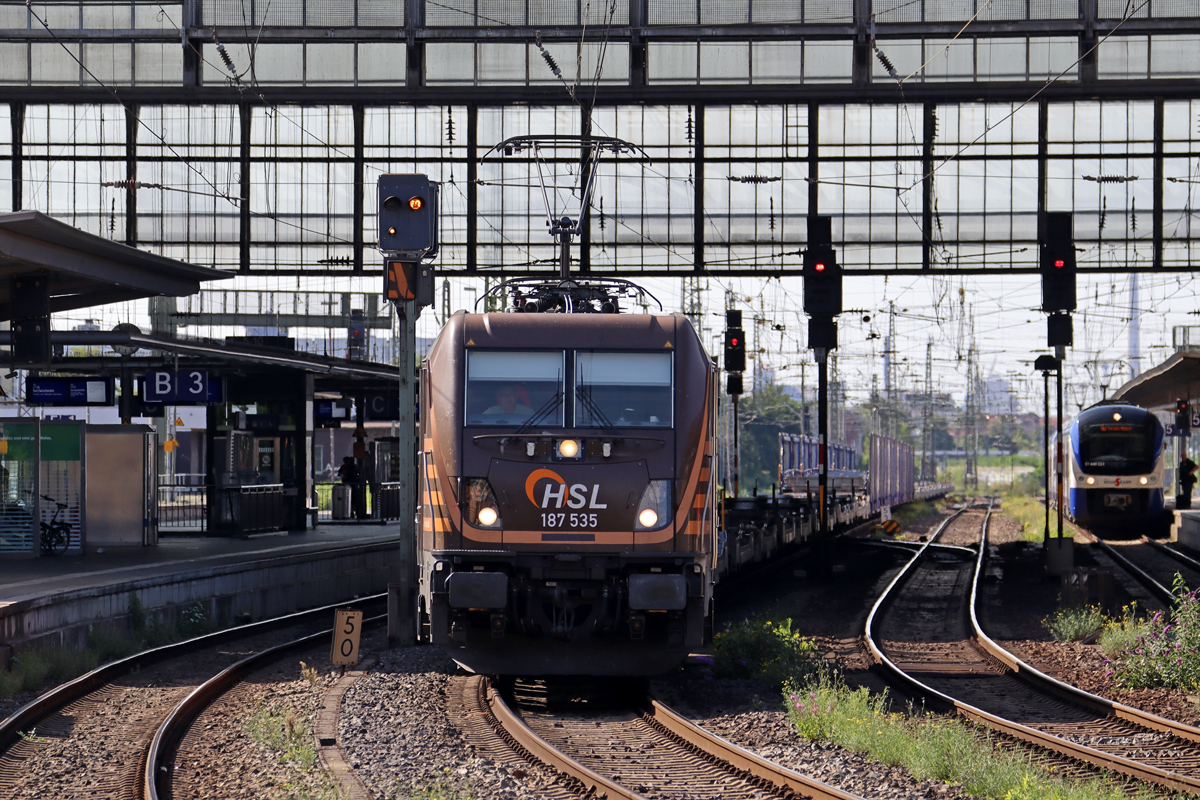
[1046,403,1165,536]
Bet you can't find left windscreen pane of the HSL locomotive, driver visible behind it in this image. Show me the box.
[466,350,563,427]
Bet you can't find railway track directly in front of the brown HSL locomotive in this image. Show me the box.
[464,678,862,800]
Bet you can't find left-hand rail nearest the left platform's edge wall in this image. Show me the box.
[0,594,388,748]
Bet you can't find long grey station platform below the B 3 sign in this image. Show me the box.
[0,523,402,666]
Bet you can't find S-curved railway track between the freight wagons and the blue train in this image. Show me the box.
[866,509,1200,793]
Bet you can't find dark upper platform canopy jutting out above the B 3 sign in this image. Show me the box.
[0,211,232,320]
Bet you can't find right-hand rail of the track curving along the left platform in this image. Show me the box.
[142,618,388,800]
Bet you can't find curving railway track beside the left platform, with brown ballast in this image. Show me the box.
[0,595,385,800]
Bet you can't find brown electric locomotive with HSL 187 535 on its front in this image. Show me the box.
[419,279,718,675]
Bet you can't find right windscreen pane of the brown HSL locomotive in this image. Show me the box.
[575,350,674,428]
